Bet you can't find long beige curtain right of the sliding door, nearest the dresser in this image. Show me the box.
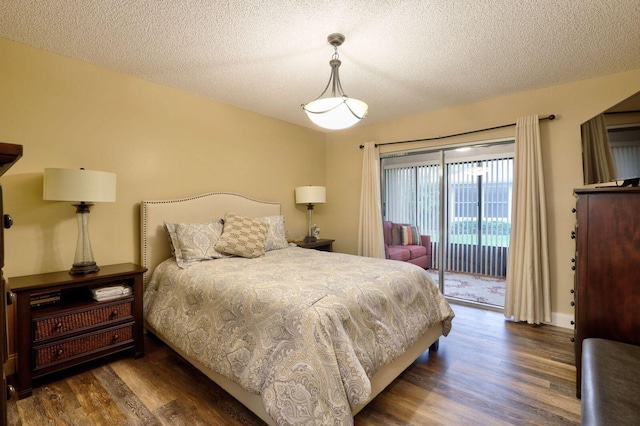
[504,115,551,324]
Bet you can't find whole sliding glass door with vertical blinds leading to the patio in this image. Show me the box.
[382,141,513,306]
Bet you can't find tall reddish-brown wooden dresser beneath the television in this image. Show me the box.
[573,187,640,397]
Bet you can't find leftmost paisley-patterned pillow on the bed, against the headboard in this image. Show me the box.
[164,221,229,269]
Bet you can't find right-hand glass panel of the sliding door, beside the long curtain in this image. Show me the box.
[443,144,513,307]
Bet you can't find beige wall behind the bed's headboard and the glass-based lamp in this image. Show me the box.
[0,39,325,277]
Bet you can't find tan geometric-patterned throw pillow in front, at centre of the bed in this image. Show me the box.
[216,212,268,258]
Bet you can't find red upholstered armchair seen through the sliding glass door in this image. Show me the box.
[383,220,431,269]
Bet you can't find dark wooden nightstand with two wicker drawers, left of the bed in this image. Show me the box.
[9,263,146,398]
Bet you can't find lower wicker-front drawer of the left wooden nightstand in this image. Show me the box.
[33,324,133,368]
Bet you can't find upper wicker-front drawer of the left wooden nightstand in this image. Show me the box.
[33,299,133,342]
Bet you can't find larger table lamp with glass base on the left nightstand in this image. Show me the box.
[42,169,116,275]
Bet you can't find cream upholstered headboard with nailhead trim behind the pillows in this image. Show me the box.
[140,192,281,284]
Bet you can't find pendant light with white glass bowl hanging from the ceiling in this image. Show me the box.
[302,33,369,130]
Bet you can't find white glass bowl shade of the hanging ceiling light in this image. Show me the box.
[304,96,369,130]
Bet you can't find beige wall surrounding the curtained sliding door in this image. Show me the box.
[322,69,640,325]
